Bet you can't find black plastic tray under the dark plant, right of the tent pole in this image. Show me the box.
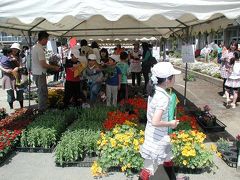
[196,117,227,133]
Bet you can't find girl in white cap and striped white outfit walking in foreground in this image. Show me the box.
[140,62,181,179]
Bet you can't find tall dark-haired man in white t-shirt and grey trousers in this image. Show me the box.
[32,31,59,111]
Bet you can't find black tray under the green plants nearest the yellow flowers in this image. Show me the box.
[56,156,97,167]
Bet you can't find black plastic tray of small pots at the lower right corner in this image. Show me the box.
[220,146,238,168]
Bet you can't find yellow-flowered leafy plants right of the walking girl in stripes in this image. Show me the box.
[170,130,216,172]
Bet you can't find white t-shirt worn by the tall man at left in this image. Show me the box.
[32,43,47,75]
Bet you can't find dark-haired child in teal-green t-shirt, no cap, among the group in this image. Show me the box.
[117,51,129,102]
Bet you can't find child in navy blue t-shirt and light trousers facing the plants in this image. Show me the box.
[104,55,121,106]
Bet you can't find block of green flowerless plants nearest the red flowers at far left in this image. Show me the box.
[20,109,75,148]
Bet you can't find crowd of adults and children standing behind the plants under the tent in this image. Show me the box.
[0,31,156,111]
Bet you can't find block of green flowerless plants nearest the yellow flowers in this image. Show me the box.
[55,106,113,165]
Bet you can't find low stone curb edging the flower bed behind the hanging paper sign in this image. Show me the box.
[174,66,223,87]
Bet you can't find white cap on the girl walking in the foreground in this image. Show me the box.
[151,62,181,78]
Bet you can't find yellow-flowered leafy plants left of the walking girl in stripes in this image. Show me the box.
[91,121,144,176]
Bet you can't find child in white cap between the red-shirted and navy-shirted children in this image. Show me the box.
[85,54,103,103]
